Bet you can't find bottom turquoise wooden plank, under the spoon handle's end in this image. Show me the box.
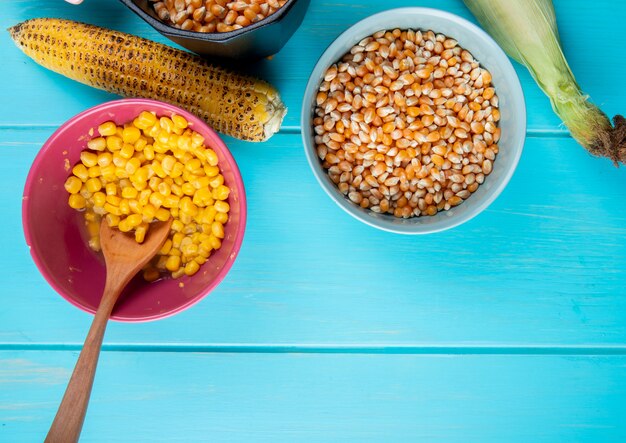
[0,351,626,443]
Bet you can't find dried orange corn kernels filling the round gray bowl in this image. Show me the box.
[313,29,500,218]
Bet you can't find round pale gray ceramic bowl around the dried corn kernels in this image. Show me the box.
[301,8,526,234]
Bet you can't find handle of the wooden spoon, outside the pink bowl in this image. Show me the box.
[45,279,121,443]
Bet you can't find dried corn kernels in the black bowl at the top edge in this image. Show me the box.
[150,0,287,32]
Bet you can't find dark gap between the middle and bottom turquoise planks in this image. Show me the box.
[0,343,626,356]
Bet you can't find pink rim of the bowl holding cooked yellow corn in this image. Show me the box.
[22,98,248,323]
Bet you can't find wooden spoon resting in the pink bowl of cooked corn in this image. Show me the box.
[45,218,172,443]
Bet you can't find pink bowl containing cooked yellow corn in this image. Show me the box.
[22,99,246,322]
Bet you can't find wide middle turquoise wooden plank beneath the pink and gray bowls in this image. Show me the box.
[0,129,626,346]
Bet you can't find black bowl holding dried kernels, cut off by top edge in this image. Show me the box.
[120,0,310,59]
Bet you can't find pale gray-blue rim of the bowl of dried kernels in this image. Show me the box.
[300,7,527,235]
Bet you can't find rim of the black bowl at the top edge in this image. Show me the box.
[120,0,298,43]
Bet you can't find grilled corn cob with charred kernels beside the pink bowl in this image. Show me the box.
[9,18,287,141]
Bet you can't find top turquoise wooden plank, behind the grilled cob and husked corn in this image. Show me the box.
[0,0,626,131]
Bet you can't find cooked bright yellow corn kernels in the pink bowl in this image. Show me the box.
[65,111,230,281]
